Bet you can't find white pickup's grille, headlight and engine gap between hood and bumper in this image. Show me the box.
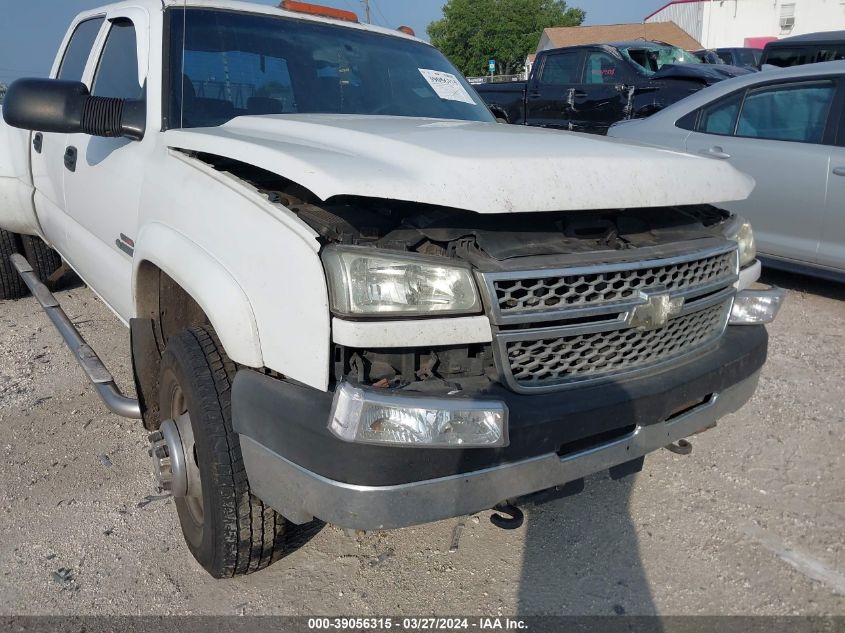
[193,156,752,394]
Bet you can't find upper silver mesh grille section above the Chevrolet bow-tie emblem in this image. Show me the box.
[493,251,736,317]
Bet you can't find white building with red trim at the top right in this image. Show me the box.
[645,0,845,48]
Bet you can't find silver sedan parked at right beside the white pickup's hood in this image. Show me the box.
[609,61,845,279]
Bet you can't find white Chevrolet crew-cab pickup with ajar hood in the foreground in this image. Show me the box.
[0,0,782,577]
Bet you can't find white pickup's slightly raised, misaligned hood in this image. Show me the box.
[164,115,754,213]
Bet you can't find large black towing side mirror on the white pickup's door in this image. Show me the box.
[3,79,147,141]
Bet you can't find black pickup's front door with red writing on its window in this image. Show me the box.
[571,49,632,134]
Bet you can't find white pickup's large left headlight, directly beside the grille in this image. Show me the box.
[323,246,481,316]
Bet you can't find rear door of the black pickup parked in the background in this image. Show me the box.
[525,50,583,129]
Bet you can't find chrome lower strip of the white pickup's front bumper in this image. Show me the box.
[241,373,759,530]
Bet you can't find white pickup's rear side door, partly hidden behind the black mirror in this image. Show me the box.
[31,17,105,251]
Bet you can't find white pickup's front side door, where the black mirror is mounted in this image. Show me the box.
[65,8,150,320]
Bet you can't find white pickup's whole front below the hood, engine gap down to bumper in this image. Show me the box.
[197,155,766,529]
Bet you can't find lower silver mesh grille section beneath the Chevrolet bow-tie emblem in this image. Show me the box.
[506,301,731,388]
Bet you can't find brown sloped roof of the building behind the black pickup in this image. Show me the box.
[537,20,702,53]
